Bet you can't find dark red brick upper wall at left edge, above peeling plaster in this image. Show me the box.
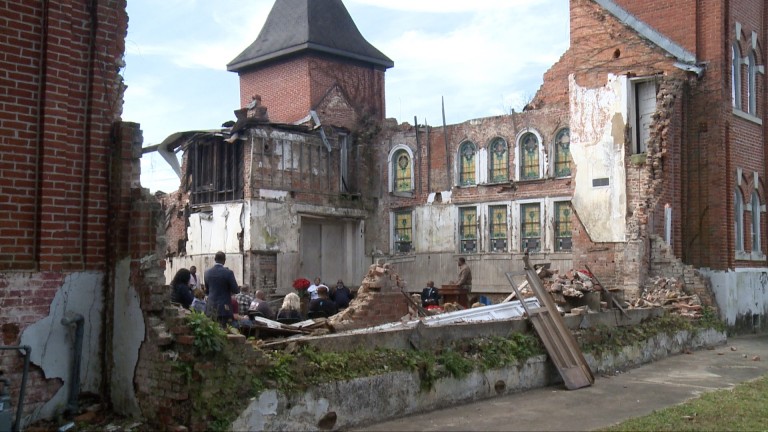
[0,0,127,271]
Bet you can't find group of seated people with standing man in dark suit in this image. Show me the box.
[171,252,352,327]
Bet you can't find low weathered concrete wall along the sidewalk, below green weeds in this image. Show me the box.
[232,323,726,431]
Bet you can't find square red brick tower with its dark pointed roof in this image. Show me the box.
[227,0,394,128]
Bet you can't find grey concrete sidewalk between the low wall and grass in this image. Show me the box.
[356,335,768,431]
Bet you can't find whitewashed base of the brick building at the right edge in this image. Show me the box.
[700,268,768,332]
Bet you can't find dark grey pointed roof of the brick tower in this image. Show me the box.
[227,0,394,72]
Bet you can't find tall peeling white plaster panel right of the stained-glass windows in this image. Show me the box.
[569,75,628,242]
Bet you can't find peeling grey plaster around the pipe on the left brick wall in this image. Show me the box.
[18,272,104,418]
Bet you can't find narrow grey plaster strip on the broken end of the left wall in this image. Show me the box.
[111,258,146,415]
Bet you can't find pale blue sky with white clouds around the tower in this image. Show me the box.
[122,0,569,192]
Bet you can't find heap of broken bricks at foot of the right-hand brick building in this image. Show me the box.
[630,276,702,318]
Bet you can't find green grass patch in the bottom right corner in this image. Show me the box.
[602,375,768,431]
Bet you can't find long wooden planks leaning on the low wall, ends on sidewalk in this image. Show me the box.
[506,254,595,390]
